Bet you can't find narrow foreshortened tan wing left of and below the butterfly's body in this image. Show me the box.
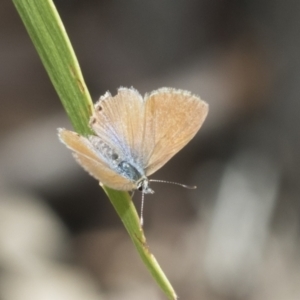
[59,129,135,191]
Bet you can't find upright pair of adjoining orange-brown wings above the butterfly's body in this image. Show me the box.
[90,88,208,175]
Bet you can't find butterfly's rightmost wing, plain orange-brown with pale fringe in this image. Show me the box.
[143,88,208,176]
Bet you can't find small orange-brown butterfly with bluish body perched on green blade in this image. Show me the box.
[58,87,208,194]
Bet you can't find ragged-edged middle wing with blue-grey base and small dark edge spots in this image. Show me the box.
[90,88,145,171]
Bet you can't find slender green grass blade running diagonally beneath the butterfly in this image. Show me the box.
[13,0,177,299]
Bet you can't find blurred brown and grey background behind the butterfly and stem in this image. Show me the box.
[0,0,300,300]
